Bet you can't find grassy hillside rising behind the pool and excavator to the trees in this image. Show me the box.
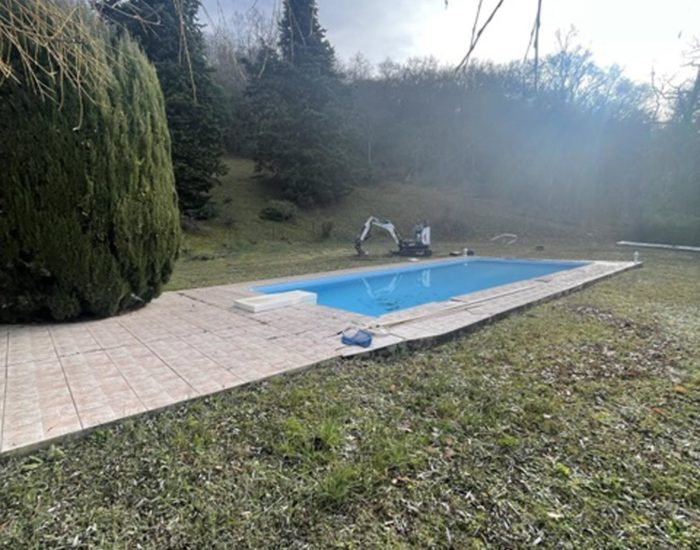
[169,159,608,290]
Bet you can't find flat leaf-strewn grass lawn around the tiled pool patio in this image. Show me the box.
[0,244,700,548]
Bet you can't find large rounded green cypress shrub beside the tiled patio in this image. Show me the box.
[0,7,180,322]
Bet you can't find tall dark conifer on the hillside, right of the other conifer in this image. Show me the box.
[247,0,361,206]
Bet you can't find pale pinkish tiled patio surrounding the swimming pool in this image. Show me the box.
[0,256,636,453]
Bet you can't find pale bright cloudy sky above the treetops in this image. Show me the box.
[203,0,700,82]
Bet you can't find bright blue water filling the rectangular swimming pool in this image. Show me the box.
[254,257,586,316]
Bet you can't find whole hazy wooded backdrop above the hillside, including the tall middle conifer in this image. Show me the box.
[209,8,700,242]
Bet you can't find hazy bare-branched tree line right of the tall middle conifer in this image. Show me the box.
[351,40,700,241]
